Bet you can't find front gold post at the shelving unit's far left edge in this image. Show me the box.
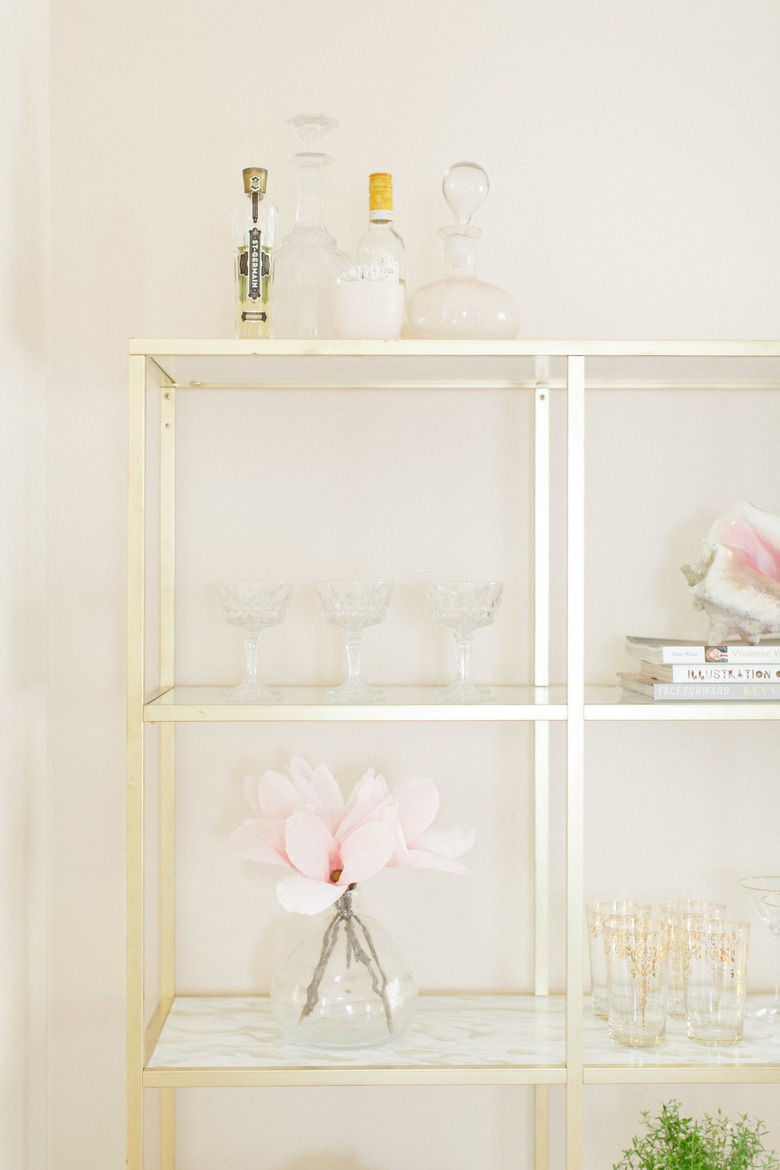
[126,356,146,1170]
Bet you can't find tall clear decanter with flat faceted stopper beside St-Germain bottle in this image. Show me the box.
[271,113,350,338]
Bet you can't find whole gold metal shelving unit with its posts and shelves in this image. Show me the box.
[127,340,780,1170]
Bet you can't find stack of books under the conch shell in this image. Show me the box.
[617,636,780,702]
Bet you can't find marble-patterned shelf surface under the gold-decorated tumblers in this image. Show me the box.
[584,996,780,1069]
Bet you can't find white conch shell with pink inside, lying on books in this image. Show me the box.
[682,503,780,646]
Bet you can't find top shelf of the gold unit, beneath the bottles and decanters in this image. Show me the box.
[130,338,780,391]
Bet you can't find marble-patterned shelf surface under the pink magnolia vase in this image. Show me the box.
[149,996,564,1068]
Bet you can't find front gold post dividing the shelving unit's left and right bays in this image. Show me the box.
[566,357,585,1170]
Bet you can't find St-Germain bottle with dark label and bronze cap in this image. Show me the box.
[233,166,277,337]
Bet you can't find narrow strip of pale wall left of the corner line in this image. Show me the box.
[0,0,50,1170]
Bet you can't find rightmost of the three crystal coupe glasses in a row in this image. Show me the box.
[426,581,504,703]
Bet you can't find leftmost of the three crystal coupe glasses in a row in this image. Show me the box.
[218,581,292,703]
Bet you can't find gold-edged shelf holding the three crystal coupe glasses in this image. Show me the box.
[144,687,566,723]
